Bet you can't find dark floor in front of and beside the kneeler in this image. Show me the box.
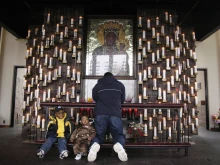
[0,126,220,165]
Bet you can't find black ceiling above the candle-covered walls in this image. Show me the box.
[0,0,220,41]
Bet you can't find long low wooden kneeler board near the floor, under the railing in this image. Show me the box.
[23,140,191,156]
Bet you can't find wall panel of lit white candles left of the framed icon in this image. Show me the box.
[22,8,84,135]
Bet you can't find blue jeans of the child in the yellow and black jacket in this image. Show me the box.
[40,137,67,154]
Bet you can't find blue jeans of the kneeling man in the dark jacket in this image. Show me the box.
[91,115,125,146]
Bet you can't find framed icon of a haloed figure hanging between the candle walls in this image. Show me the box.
[85,17,134,76]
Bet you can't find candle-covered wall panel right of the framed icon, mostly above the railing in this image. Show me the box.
[136,8,198,134]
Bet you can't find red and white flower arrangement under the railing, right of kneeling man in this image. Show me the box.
[127,122,144,139]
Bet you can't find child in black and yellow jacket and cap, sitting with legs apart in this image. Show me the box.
[37,107,72,159]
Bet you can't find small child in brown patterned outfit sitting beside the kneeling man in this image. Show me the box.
[70,116,96,160]
